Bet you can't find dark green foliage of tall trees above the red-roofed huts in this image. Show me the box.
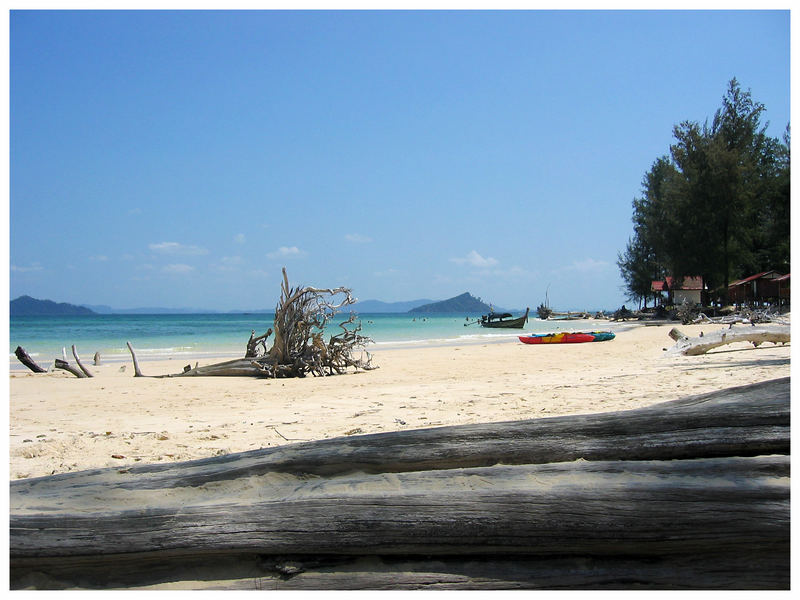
[617,79,790,305]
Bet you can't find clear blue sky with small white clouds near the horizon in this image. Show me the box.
[9,11,790,310]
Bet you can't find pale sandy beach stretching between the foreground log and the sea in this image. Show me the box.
[9,324,791,479]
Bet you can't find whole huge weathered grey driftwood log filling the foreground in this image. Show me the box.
[10,378,790,589]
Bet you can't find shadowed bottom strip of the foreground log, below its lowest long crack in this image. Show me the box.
[12,549,788,590]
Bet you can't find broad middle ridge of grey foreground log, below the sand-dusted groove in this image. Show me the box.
[11,456,789,557]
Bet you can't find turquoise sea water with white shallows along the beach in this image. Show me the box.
[9,313,612,370]
